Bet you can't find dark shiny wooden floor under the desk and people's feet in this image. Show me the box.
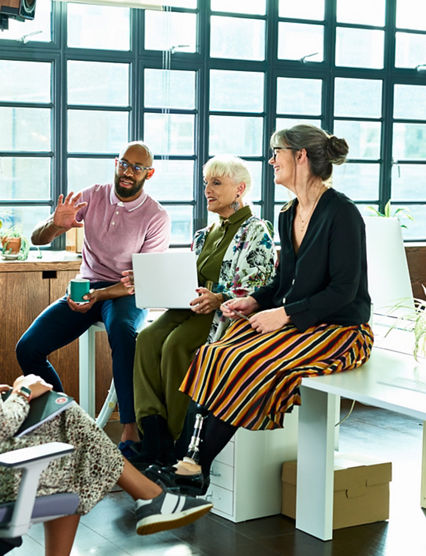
[12,401,426,556]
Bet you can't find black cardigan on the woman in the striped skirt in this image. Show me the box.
[252,189,371,332]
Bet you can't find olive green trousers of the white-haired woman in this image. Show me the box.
[133,309,214,439]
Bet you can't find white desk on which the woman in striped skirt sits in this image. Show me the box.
[296,347,426,540]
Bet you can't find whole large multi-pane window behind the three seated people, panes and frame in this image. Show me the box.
[0,0,426,247]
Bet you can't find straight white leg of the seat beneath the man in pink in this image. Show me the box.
[78,326,96,417]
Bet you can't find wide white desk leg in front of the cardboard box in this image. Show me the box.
[296,386,336,541]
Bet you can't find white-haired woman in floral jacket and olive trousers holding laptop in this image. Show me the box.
[123,155,276,468]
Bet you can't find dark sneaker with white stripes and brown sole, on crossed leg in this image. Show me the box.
[136,490,213,535]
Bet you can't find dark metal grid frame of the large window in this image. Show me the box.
[0,0,426,245]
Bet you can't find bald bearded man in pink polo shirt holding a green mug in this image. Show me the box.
[16,141,170,455]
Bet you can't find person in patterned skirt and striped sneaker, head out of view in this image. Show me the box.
[0,374,212,556]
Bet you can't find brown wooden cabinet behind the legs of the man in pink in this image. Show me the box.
[0,252,111,411]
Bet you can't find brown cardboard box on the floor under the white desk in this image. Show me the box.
[281,454,392,529]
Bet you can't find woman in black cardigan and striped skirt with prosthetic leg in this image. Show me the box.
[146,125,373,493]
